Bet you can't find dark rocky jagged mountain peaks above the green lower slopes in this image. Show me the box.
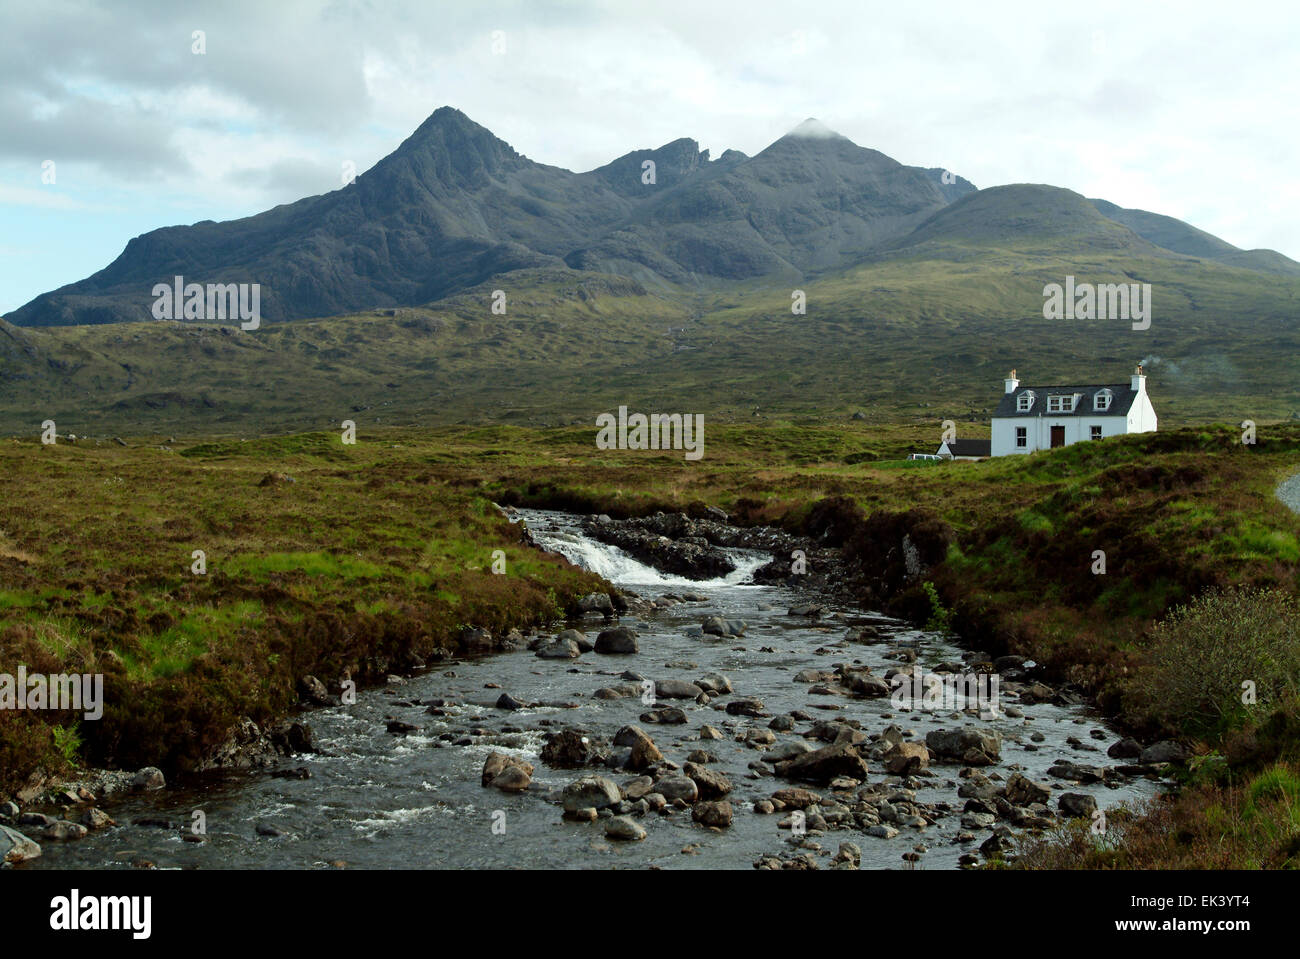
[5,107,974,326]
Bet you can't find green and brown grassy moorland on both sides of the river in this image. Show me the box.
[0,420,1300,864]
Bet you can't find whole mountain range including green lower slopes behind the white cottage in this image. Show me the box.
[0,109,1300,438]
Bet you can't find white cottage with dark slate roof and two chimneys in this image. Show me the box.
[992,366,1156,456]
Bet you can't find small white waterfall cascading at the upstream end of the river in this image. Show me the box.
[517,509,772,590]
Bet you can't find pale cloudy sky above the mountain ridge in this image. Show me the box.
[0,0,1300,313]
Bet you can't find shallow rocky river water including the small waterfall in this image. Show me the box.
[23,511,1157,869]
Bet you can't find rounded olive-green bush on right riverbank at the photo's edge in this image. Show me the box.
[1141,589,1300,734]
